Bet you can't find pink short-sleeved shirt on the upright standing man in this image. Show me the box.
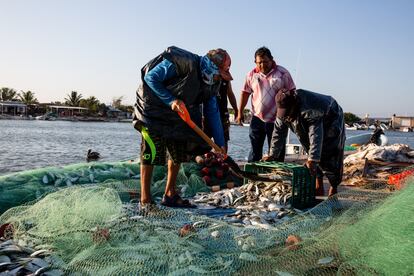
[242,65,296,123]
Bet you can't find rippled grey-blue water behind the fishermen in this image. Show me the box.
[0,120,414,175]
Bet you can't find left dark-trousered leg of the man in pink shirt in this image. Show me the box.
[247,116,266,162]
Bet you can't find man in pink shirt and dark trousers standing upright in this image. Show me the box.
[236,47,296,162]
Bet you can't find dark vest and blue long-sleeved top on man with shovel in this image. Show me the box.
[134,46,224,146]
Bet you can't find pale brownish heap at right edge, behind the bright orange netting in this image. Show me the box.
[343,144,414,185]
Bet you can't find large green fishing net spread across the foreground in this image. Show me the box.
[0,172,414,275]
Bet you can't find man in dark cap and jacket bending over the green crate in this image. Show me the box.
[263,89,345,196]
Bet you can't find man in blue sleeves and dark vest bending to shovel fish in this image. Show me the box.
[134,46,232,208]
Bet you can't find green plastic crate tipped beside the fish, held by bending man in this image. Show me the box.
[244,162,315,209]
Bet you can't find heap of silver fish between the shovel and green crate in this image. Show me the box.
[194,177,300,229]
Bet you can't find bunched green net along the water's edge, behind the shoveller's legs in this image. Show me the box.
[0,161,209,214]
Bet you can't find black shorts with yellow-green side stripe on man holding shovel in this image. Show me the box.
[141,130,189,166]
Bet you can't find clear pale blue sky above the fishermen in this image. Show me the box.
[0,0,414,116]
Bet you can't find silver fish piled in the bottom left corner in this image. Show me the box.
[0,238,64,276]
